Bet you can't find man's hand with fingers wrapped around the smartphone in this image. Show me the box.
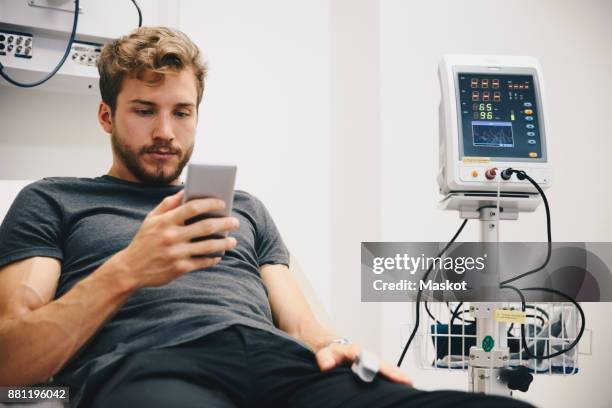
[114,190,239,289]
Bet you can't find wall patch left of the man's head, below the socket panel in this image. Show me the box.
[0,87,112,180]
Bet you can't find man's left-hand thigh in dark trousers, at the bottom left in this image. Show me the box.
[80,327,250,408]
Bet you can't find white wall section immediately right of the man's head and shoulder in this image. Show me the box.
[179,0,331,309]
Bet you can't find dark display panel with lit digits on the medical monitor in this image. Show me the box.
[458,72,545,161]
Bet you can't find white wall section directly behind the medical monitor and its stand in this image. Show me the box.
[380,0,612,407]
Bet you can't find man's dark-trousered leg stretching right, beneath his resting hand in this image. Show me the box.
[240,327,531,408]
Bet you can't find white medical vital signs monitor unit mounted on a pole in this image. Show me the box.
[438,55,551,194]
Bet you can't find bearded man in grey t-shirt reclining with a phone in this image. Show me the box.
[0,27,525,407]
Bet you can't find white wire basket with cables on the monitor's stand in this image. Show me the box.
[415,302,580,375]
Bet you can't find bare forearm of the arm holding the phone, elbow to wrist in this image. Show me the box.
[0,258,133,385]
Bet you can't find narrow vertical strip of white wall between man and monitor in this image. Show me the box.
[331,0,381,351]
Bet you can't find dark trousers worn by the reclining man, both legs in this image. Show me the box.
[83,326,531,408]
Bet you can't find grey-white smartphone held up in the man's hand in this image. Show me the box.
[183,163,237,258]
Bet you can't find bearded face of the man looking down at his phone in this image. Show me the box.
[98,69,197,186]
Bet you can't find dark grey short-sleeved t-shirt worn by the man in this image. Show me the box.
[0,175,305,402]
